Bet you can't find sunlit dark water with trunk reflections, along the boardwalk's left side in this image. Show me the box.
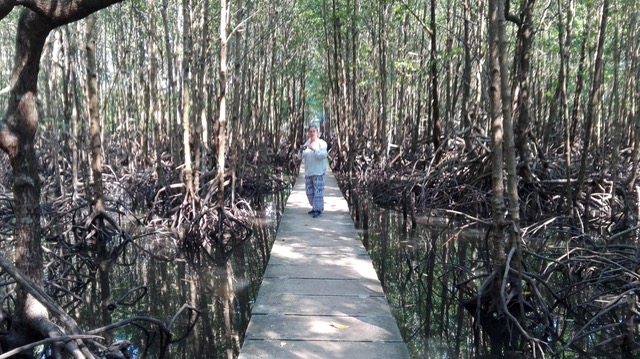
[94,193,288,359]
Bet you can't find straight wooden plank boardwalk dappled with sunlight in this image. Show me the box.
[239,171,409,359]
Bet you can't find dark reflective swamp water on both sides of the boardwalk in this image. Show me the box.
[87,186,479,359]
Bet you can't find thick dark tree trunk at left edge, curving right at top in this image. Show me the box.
[0,0,120,358]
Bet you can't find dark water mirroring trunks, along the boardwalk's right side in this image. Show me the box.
[352,201,482,358]
